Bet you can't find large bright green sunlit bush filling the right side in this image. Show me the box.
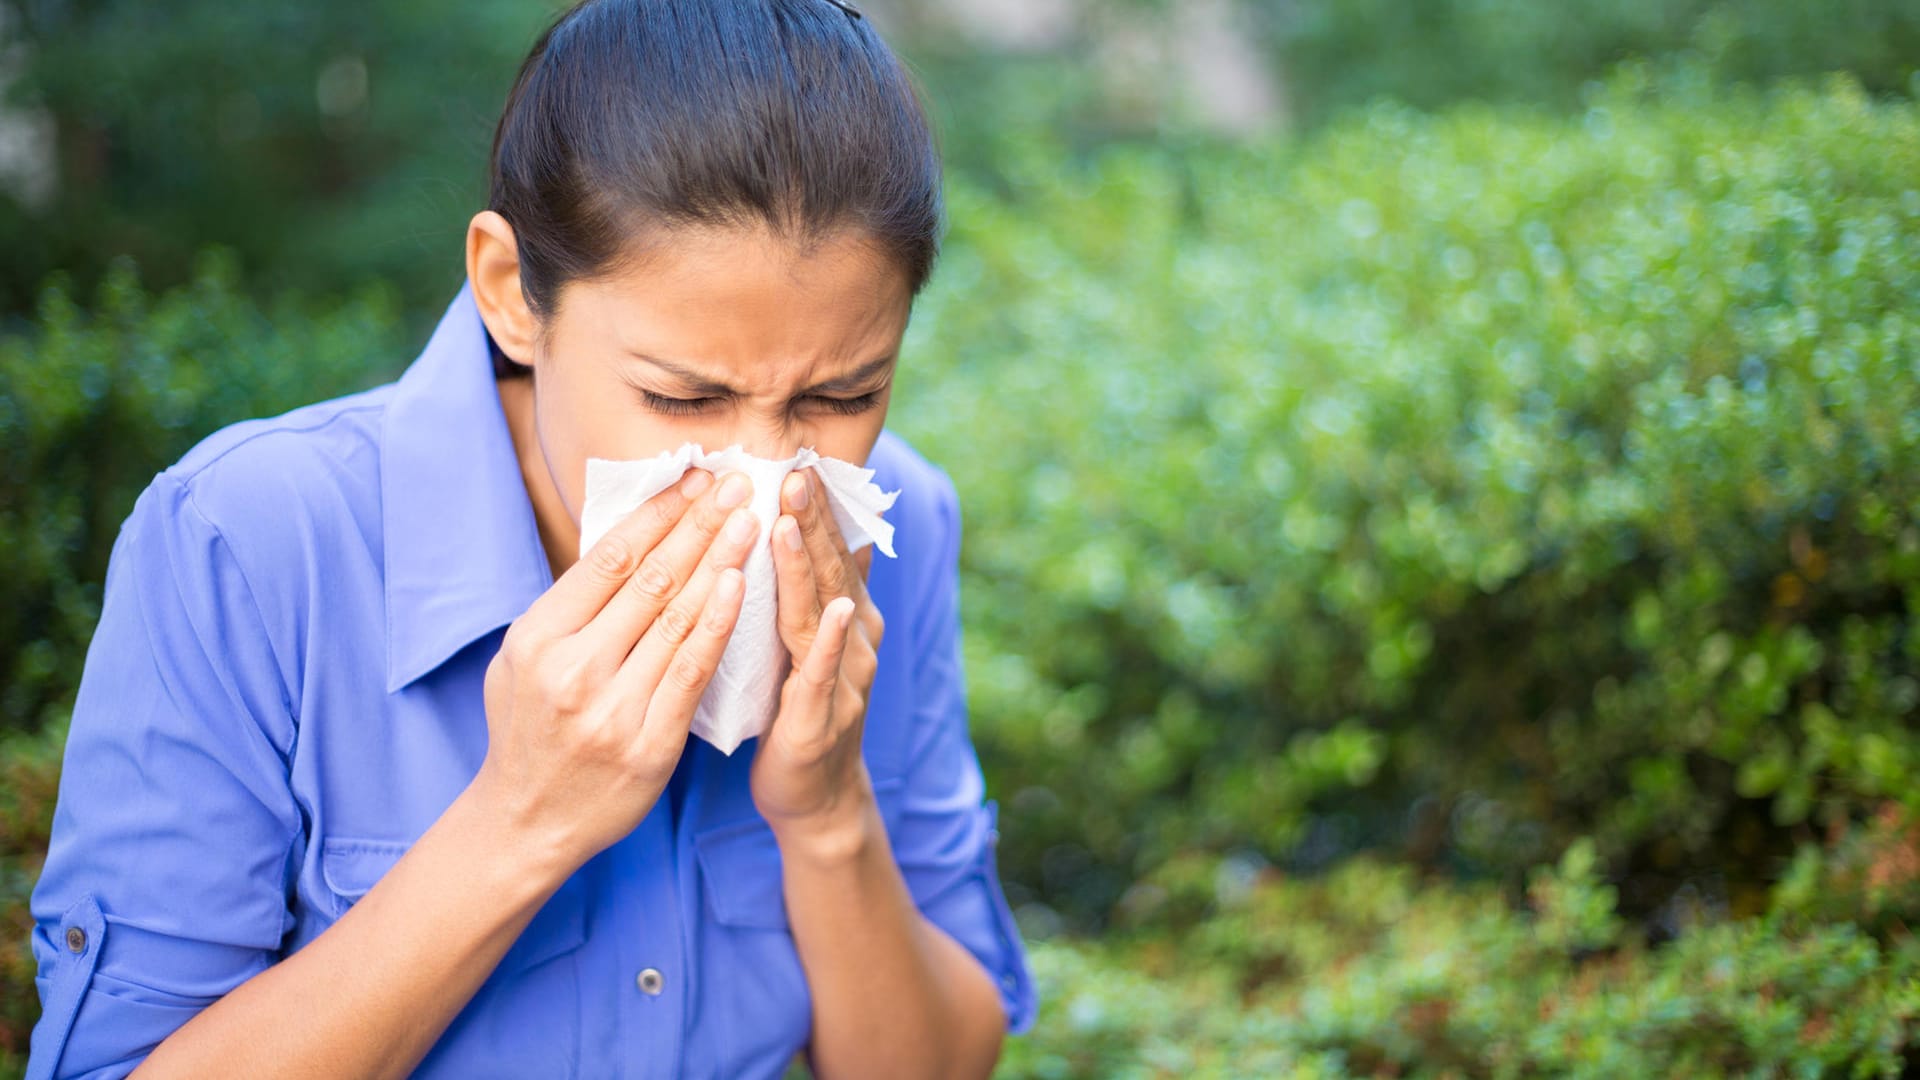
[895,67,1920,922]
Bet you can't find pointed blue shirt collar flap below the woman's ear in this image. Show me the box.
[380,282,553,694]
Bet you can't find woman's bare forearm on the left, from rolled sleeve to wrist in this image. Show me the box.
[134,768,572,1080]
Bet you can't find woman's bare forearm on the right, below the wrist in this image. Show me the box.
[780,776,1006,1080]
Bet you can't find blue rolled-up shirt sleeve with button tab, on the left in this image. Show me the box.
[27,473,303,1080]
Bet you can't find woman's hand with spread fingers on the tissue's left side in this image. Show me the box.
[468,469,758,878]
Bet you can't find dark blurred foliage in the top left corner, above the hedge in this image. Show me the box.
[0,0,561,329]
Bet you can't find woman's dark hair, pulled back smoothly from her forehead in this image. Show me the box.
[488,0,943,375]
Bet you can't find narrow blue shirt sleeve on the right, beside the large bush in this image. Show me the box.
[889,471,1039,1034]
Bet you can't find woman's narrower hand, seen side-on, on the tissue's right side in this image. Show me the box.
[751,469,883,834]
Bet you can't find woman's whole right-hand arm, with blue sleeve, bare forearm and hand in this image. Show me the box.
[753,465,1031,1078]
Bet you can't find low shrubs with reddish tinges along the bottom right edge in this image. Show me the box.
[996,859,1920,1080]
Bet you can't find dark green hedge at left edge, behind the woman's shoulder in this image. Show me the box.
[0,252,409,737]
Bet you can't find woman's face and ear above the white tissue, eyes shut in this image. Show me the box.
[468,211,912,564]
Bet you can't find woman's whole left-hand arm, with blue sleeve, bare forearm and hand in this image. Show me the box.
[33,471,758,1078]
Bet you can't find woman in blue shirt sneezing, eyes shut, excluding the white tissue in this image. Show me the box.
[31,0,1035,1078]
